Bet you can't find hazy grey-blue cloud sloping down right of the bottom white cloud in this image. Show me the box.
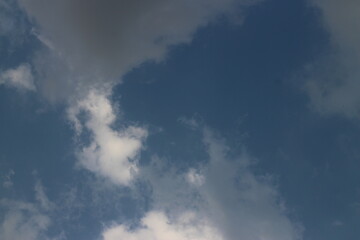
[200,129,301,240]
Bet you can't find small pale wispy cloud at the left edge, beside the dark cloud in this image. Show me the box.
[0,63,36,91]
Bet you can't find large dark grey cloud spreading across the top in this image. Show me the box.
[15,0,258,99]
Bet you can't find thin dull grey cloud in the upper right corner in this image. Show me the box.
[306,0,360,118]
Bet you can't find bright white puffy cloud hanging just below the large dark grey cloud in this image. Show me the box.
[68,90,147,185]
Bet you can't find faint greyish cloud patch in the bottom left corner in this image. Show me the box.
[0,182,51,240]
